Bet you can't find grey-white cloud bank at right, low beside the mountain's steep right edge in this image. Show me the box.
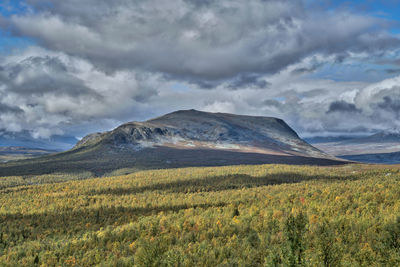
[253,81,400,136]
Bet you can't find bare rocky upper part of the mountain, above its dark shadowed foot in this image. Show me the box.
[75,109,327,157]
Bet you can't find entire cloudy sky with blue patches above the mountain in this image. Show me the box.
[0,0,400,143]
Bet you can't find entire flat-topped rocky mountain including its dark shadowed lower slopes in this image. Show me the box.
[0,110,343,175]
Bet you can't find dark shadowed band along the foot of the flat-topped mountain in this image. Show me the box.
[0,147,348,177]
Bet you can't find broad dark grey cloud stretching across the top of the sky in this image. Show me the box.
[4,0,399,84]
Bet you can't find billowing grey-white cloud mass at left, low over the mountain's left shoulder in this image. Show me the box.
[0,49,162,138]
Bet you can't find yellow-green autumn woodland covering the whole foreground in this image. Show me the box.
[0,165,400,266]
